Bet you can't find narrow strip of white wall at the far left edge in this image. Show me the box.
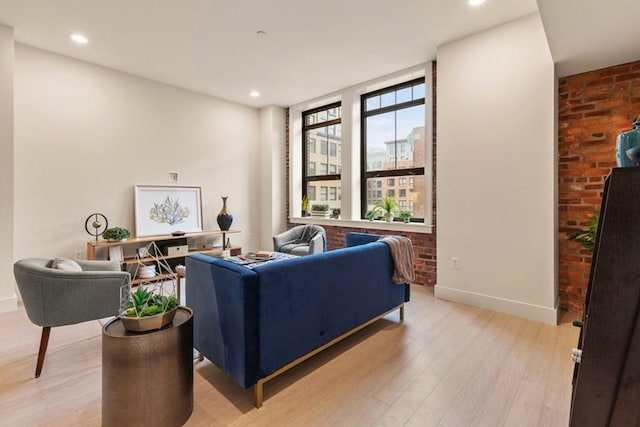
[0,25,17,313]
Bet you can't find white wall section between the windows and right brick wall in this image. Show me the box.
[435,15,558,324]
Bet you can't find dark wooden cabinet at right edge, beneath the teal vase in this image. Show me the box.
[570,168,640,427]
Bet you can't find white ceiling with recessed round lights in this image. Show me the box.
[0,0,640,107]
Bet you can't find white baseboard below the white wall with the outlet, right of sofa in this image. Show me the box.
[434,285,560,325]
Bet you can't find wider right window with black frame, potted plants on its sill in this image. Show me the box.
[360,78,426,219]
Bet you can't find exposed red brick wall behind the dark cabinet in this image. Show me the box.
[558,61,640,311]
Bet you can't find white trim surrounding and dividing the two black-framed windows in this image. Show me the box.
[289,62,434,233]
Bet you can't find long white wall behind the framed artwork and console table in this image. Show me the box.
[14,44,260,259]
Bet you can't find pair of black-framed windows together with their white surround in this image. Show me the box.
[288,63,435,227]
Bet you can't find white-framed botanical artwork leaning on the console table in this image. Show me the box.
[134,185,202,237]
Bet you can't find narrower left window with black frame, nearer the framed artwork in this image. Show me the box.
[302,102,342,208]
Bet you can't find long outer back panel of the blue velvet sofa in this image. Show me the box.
[254,243,408,375]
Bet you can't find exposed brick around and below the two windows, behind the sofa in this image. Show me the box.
[285,62,437,286]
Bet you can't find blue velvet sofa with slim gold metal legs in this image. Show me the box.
[186,233,409,408]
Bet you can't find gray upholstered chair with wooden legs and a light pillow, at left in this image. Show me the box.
[13,258,131,378]
